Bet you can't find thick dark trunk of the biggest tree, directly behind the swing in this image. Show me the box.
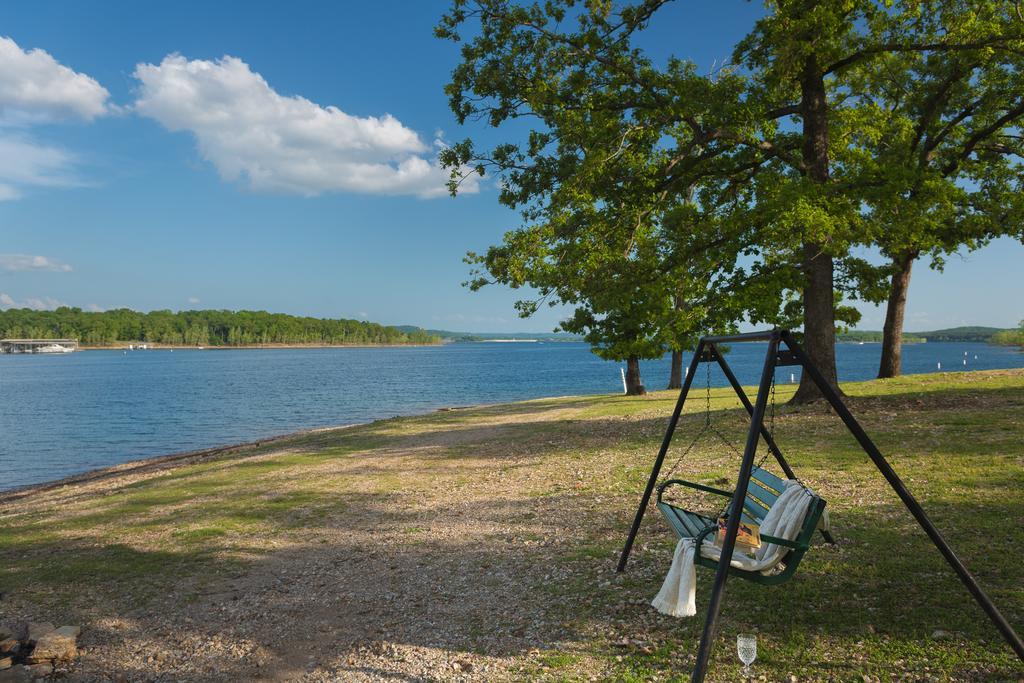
[792,54,840,403]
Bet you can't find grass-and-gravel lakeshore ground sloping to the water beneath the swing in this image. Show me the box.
[0,372,1024,682]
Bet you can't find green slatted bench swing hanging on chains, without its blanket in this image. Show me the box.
[656,358,834,586]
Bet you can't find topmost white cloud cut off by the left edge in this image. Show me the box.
[0,37,111,125]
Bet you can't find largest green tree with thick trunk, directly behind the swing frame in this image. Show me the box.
[438,0,1020,401]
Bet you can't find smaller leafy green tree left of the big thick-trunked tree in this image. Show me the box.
[468,159,728,395]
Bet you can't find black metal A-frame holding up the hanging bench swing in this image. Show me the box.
[617,330,1024,682]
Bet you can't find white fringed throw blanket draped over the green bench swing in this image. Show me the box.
[650,479,812,616]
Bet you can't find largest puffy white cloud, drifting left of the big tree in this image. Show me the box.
[134,54,478,198]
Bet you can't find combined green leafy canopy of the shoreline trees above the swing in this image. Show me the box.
[436,0,1024,400]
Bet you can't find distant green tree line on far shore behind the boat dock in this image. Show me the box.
[0,307,440,346]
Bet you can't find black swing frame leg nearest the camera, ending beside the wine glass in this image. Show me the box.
[690,334,779,683]
